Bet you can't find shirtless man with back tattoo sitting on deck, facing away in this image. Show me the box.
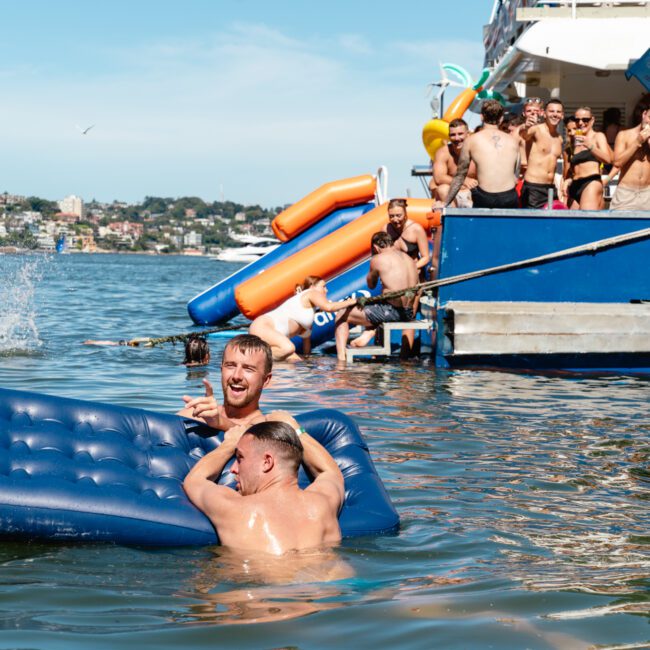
[434,99,519,209]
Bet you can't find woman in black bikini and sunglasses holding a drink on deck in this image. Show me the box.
[565,106,613,210]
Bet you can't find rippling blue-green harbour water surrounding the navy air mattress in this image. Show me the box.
[0,255,650,650]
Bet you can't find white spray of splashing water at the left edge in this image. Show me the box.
[0,255,45,356]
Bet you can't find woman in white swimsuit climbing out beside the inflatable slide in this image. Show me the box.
[248,275,356,361]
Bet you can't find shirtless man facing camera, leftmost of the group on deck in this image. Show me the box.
[429,119,478,208]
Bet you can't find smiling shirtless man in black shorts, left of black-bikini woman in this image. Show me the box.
[520,99,564,209]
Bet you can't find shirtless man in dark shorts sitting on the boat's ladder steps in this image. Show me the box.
[334,231,418,361]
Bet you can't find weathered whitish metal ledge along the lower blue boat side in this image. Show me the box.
[439,300,650,356]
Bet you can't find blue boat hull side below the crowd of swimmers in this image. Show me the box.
[436,210,650,373]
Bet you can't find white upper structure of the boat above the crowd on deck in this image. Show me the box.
[473,0,650,125]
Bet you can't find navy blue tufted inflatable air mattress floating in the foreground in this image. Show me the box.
[0,389,399,546]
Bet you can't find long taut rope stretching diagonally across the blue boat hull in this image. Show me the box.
[356,228,650,307]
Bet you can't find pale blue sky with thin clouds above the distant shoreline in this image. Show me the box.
[0,0,492,207]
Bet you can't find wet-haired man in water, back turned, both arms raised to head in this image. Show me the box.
[183,421,345,555]
